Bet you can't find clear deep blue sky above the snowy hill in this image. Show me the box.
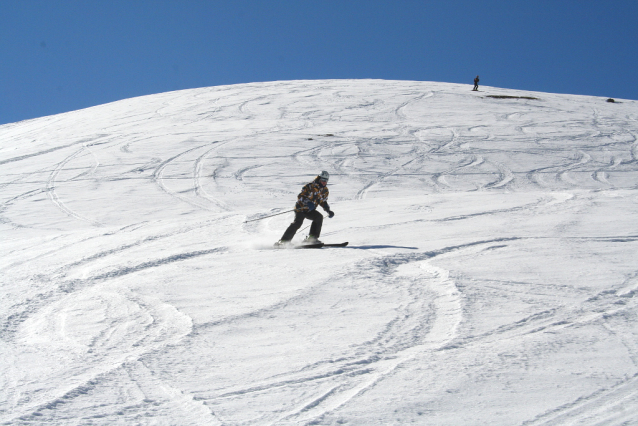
[0,0,638,124]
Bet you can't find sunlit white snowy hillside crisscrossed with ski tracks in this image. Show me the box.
[0,80,638,426]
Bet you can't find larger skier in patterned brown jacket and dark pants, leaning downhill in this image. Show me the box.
[275,170,335,247]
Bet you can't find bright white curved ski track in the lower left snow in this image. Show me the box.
[5,288,191,423]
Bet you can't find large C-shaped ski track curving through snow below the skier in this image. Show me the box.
[192,243,462,423]
